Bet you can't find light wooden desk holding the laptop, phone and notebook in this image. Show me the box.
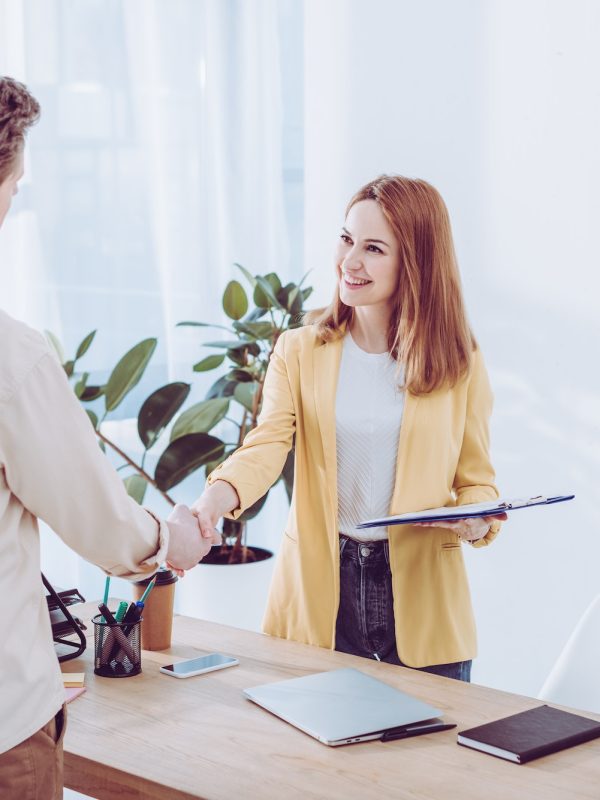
[62,604,600,800]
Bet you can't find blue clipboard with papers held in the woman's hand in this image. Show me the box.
[356,494,575,530]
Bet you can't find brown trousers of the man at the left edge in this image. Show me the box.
[0,705,67,800]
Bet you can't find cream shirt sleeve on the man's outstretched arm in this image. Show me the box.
[0,351,168,580]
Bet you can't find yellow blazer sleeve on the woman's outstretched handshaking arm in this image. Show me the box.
[207,333,296,519]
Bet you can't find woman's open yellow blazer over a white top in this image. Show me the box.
[209,326,500,667]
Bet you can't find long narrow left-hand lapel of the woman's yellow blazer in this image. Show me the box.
[313,338,343,534]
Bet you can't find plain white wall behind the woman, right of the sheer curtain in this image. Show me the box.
[304,0,600,694]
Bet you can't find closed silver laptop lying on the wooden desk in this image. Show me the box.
[244,669,446,747]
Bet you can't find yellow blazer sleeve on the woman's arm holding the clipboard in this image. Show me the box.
[453,349,502,547]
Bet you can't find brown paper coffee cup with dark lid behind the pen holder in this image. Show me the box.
[133,567,177,650]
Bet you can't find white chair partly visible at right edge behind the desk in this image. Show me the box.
[538,595,600,714]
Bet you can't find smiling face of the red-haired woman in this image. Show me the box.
[336,200,400,307]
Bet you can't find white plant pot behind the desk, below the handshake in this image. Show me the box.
[175,547,275,631]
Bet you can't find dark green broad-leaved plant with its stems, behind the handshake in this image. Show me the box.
[47,264,312,564]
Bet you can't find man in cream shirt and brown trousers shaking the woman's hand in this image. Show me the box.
[0,78,220,800]
